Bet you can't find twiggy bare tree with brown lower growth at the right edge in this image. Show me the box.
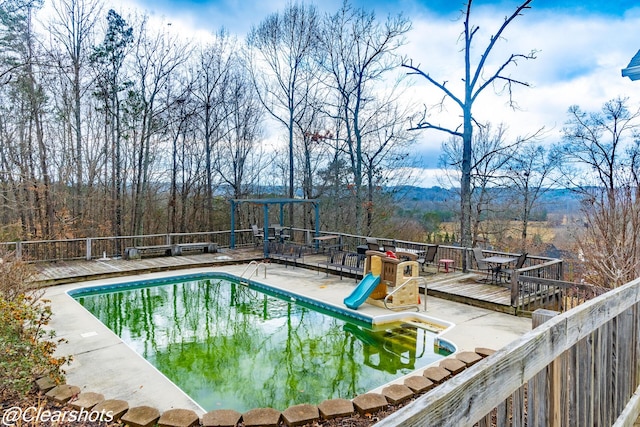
[559,98,640,288]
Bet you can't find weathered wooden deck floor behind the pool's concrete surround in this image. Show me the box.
[35,248,515,314]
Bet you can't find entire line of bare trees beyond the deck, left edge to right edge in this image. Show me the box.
[5,0,640,286]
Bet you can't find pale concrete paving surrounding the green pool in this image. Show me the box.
[44,264,531,415]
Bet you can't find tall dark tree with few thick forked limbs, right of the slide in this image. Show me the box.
[403,0,536,271]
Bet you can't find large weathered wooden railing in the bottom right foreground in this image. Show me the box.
[376,279,640,427]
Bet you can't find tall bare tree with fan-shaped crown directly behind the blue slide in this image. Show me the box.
[319,1,411,233]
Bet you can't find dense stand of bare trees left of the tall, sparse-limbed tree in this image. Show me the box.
[0,0,414,240]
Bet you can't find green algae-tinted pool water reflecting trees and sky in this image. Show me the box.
[70,278,449,412]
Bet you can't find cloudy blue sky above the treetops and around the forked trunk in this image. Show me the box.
[105,0,640,187]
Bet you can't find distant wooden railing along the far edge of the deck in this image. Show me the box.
[0,228,603,313]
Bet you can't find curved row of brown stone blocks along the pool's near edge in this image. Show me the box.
[36,347,495,427]
